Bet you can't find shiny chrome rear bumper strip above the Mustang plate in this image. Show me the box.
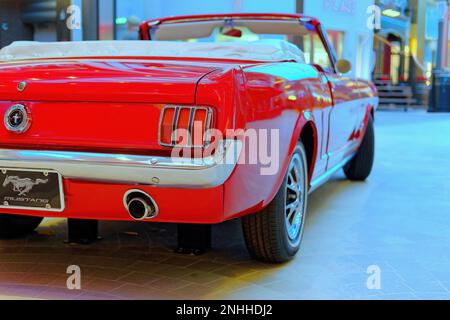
[0,140,242,188]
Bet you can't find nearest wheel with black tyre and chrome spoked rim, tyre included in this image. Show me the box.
[242,142,308,263]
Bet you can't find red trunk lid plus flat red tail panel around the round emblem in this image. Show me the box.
[0,59,217,154]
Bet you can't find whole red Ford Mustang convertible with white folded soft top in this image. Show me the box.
[0,14,378,262]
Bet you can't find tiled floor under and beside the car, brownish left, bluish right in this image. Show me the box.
[0,112,450,299]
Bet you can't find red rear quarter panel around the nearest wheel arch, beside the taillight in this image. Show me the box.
[197,62,331,220]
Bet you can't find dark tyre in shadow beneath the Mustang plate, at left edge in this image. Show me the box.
[0,214,43,239]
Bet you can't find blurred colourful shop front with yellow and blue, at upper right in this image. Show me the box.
[374,0,450,84]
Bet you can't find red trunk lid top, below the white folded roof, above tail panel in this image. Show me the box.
[0,58,215,103]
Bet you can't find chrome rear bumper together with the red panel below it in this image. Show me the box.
[0,140,242,224]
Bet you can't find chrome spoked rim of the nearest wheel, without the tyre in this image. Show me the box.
[285,154,306,241]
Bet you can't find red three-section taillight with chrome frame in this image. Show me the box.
[159,106,213,148]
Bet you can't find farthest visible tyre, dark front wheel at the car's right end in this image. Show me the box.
[344,116,375,181]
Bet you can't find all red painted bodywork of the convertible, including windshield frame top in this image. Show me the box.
[0,14,376,223]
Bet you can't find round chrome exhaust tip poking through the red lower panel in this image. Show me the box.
[123,190,158,221]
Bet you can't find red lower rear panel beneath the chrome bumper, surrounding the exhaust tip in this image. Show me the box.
[1,179,225,224]
